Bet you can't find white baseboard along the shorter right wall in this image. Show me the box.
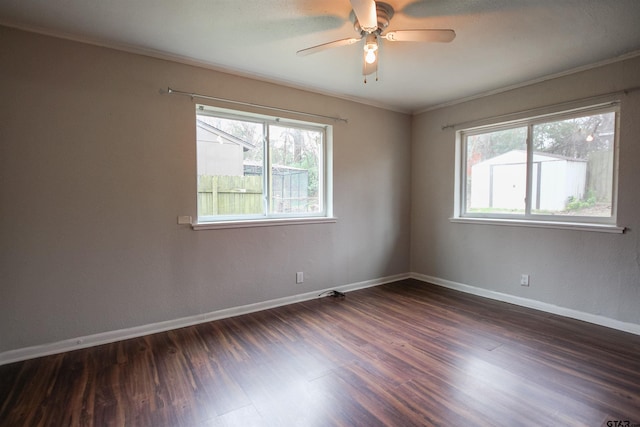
[409,273,640,335]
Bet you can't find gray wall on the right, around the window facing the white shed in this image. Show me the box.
[411,57,640,325]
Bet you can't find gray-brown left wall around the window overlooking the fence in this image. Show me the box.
[0,27,411,354]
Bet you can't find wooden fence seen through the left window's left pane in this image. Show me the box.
[198,175,263,216]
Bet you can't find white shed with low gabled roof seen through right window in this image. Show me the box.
[471,150,587,211]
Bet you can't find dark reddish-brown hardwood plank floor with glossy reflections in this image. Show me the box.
[0,280,640,427]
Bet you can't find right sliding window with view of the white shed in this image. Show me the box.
[456,103,619,229]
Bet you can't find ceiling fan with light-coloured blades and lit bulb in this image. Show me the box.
[296,0,456,83]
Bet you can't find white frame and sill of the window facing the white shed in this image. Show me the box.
[450,100,625,233]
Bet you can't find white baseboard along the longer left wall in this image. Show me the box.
[0,273,410,366]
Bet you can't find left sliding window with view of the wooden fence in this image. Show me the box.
[196,105,331,224]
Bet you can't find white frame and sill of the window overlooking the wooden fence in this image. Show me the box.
[191,103,336,230]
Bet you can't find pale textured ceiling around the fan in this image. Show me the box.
[0,0,640,112]
